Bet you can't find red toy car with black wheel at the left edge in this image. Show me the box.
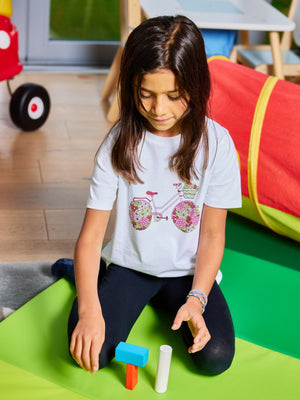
[0,0,50,131]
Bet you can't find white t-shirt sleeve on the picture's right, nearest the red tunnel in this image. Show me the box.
[204,129,242,208]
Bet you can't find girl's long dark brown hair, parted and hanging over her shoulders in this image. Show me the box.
[111,16,210,183]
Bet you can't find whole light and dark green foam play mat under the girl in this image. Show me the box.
[0,250,300,400]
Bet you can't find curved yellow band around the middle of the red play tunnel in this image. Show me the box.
[248,76,280,233]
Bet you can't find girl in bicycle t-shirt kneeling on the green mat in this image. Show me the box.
[69,16,241,375]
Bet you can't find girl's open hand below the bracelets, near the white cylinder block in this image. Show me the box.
[171,297,211,353]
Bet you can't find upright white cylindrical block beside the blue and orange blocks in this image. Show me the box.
[154,344,172,393]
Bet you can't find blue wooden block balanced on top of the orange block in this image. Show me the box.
[115,342,149,367]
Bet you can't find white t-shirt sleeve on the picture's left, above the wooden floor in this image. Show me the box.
[87,139,119,210]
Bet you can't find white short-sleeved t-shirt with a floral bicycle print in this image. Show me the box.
[87,119,241,277]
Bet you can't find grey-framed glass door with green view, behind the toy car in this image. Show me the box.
[12,0,120,67]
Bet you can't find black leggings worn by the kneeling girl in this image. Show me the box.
[68,261,235,375]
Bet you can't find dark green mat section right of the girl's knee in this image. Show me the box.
[220,249,300,358]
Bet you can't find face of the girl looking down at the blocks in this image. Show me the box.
[136,69,187,136]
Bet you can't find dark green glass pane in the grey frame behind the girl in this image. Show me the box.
[49,0,120,40]
